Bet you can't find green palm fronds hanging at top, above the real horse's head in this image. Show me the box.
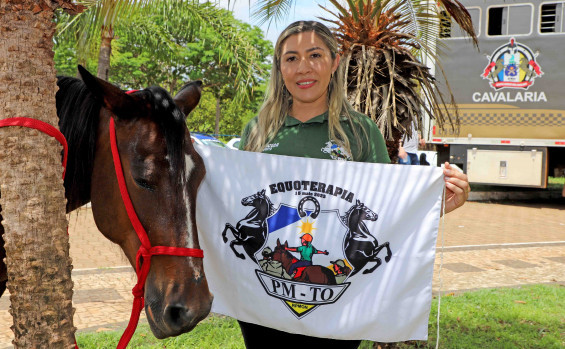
[61,0,266,92]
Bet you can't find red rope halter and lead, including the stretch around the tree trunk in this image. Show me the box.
[0,117,204,349]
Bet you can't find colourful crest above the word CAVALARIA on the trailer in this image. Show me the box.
[482,38,543,90]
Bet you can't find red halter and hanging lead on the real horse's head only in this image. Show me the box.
[110,118,204,349]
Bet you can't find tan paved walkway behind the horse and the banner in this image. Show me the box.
[0,200,565,348]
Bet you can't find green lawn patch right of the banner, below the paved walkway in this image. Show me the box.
[364,285,565,349]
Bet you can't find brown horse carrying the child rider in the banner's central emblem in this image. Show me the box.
[272,239,337,285]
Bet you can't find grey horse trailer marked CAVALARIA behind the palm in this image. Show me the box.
[426,0,565,188]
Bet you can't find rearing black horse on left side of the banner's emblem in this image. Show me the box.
[222,189,275,263]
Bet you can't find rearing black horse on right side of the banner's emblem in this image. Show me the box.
[340,200,392,277]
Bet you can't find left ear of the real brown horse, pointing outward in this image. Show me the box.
[78,65,143,119]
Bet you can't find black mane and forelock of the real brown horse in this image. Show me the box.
[56,77,186,208]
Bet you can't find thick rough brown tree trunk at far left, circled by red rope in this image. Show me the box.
[0,0,76,348]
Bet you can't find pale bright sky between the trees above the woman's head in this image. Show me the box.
[220,0,334,44]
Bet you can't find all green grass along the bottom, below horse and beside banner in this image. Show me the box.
[77,285,565,349]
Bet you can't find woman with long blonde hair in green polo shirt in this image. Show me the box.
[239,21,469,349]
